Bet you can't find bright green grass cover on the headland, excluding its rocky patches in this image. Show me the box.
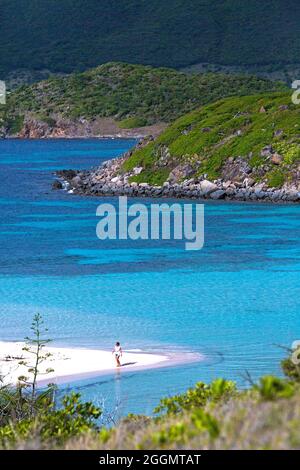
[124,93,300,186]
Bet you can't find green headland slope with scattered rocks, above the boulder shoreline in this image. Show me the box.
[123,93,300,188]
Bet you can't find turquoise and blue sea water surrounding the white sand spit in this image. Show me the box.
[0,140,300,413]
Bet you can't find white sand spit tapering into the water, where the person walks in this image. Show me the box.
[0,341,202,385]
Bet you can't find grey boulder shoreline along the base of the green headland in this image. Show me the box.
[53,143,300,203]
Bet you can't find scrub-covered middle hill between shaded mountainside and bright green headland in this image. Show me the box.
[0,63,284,134]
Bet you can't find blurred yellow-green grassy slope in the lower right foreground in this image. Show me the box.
[82,392,300,450]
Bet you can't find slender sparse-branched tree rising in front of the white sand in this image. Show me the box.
[18,313,53,412]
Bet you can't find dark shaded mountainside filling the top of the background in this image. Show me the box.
[0,0,300,78]
